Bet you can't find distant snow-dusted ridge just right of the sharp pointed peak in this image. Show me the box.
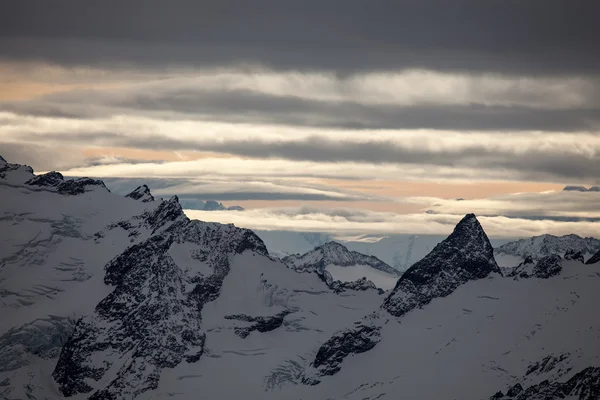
[495,235,600,267]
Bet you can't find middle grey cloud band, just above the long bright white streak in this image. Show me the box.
[0,91,600,132]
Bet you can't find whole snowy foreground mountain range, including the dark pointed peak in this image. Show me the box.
[0,155,600,400]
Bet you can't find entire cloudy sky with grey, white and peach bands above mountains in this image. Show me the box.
[0,0,600,237]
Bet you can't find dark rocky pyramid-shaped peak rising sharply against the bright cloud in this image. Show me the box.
[382,214,500,317]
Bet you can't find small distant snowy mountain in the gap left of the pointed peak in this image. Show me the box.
[282,242,400,290]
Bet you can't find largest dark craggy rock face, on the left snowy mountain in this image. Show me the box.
[53,197,271,399]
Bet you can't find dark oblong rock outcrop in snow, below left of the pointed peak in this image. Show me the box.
[304,318,381,384]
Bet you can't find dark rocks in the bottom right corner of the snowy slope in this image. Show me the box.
[497,367,600,400]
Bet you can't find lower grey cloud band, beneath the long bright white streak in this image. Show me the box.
[15,132,600,184]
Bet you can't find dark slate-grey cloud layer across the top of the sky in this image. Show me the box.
[0,0,600,74]
